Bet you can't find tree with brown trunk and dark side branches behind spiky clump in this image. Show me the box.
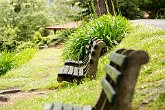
[70,0,117,17]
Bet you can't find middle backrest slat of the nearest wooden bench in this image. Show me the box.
[105,64,121,83]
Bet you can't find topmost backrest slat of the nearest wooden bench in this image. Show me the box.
[109,53,128,67]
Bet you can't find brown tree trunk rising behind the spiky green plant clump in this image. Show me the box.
[94,0,117,16]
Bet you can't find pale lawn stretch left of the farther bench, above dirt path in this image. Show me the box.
[0,48,61,90]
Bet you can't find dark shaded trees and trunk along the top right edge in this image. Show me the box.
[71,0,165,19]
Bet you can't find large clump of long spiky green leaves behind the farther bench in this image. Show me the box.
[63,15,129,59]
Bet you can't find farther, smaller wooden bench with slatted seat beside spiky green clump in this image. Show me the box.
[57,40,105,82]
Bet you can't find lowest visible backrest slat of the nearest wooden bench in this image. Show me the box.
[101,78,116,103]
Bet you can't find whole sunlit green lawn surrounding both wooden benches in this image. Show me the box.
[0,26,165,110]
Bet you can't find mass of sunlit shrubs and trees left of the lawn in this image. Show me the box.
[0,0,79,75]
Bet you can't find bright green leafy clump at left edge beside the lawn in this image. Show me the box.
[0,51,14,76]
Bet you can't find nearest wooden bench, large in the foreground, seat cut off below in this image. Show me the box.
[44,49,149,110]
